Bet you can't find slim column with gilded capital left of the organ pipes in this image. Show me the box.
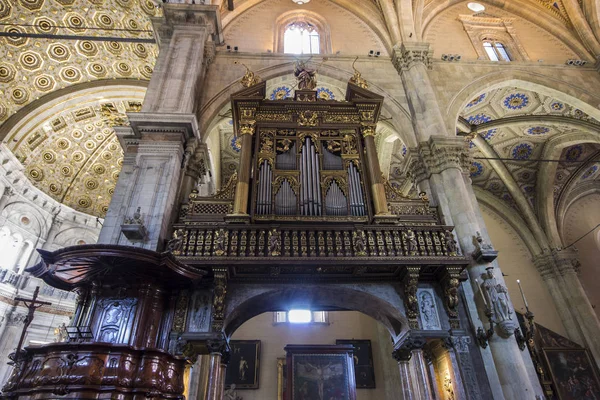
[233,125,255,216]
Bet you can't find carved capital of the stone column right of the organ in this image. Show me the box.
[408,136,472,183]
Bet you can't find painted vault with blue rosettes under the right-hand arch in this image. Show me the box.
[461,87,600,217]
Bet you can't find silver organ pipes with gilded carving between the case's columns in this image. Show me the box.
[252,128,367,219]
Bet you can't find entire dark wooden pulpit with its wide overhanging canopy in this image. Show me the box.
[3,245,205,400]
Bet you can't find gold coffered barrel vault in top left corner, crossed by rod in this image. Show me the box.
[0,0,160,123]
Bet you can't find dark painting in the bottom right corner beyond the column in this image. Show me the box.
[543,348,600,400]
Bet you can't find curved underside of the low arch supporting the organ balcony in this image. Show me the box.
[224,284,409,342]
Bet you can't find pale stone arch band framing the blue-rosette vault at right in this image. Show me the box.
[445,70,600,132]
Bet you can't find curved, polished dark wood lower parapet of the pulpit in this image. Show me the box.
[4,343,185,400]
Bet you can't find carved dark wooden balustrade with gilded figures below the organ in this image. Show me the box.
[169,224,464,261]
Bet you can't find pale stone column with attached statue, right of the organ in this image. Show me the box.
[413,137,543,399]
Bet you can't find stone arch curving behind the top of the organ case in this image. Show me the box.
[197,64,417,147]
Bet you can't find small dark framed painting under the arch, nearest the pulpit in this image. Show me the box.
[225,340,260,389]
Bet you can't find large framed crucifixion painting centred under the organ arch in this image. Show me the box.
[285,345,356,400]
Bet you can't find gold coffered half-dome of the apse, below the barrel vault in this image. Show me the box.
[5,88,145,217]
